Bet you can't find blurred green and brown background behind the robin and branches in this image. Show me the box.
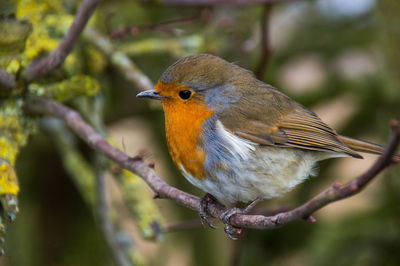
[0,0,400,266]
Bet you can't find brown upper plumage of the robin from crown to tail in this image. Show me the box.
[161,54,388,158]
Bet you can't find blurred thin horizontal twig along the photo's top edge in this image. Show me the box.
[163,0,306,6]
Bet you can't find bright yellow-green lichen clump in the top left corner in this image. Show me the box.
[0,0,78,74]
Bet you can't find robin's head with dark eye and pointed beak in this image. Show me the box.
[137,54,254,112]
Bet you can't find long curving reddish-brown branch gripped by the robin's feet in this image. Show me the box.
[26,98,400,229]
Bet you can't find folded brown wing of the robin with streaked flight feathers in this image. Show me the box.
[220,84,362,158]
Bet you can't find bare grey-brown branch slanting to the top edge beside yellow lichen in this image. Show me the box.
[24,0,101,82]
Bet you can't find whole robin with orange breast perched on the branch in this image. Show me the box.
[137,54,396,237]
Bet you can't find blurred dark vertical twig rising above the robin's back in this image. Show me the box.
[256,3,272,80]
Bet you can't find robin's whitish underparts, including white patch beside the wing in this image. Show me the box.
[180,121,334,203]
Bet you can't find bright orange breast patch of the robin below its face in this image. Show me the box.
[162,82,214,180]
